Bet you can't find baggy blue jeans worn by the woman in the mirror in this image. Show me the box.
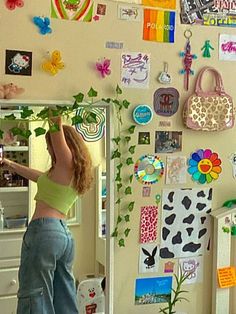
[17,218,78,314]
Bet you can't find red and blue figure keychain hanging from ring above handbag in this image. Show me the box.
[180,30,197,90]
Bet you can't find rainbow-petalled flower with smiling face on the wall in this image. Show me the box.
[188,149,222,184]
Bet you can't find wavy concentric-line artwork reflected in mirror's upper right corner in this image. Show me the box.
[75,108,106,142]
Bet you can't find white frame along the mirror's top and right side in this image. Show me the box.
[0,99,115,314]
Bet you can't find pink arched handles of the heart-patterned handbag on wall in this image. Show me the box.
[195,67,225,96]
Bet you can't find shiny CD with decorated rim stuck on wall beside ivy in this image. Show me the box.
[134,155,164,184]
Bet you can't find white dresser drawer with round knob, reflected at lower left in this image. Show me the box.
[0,268,19,296]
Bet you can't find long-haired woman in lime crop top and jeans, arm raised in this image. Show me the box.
[1,117,92,314]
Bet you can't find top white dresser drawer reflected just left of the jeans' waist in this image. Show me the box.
[0,237,22,259]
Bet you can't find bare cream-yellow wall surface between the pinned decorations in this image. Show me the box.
[0,0,236,314]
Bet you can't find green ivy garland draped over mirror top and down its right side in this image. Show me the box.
[0,85,136,247]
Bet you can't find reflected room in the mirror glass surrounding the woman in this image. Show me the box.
[0,106,107,314]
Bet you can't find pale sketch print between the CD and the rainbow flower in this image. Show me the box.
[166,156,187,184]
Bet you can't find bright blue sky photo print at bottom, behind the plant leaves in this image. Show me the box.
[135,276,172,305]
